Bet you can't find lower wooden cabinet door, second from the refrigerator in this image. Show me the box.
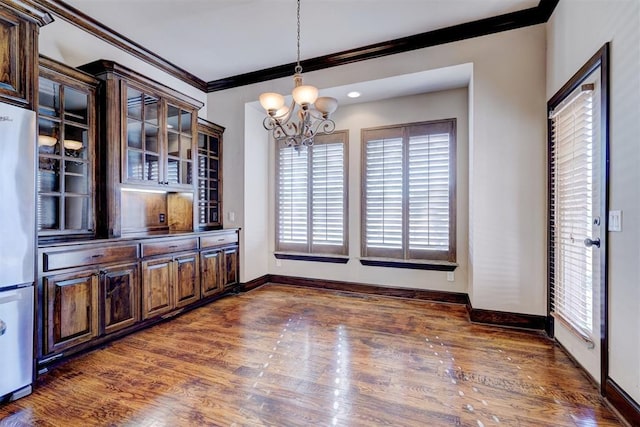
[101,264,140,334]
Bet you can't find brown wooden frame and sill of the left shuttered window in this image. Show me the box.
[274,130,349,256]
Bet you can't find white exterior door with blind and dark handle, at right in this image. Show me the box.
[549,58,607,382]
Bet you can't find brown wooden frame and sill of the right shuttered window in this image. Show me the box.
[360,118,457,264]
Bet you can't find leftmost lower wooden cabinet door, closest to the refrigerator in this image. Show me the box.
[44,271,98,353]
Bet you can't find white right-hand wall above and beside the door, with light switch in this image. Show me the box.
[547,0,640,408]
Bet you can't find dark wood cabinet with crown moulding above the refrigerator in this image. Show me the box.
[0,0,53,110]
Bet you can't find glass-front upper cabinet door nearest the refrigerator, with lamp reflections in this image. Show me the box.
[37,62,95,237]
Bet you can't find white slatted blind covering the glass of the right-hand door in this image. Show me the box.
[550,84,598,337]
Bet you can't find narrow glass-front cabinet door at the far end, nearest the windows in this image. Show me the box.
[196,119,224,229]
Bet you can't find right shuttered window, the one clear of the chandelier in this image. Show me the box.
[362,119,456,262]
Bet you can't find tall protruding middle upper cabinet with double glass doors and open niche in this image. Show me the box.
[79,60,203,238]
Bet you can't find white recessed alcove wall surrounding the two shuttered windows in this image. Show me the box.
[262,88,469,293]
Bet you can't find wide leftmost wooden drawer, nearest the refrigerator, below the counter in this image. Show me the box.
[43,245,138,271]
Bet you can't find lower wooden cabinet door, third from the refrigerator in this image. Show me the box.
[142,258,174,319]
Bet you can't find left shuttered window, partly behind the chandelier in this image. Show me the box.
[276,131,348,255]
